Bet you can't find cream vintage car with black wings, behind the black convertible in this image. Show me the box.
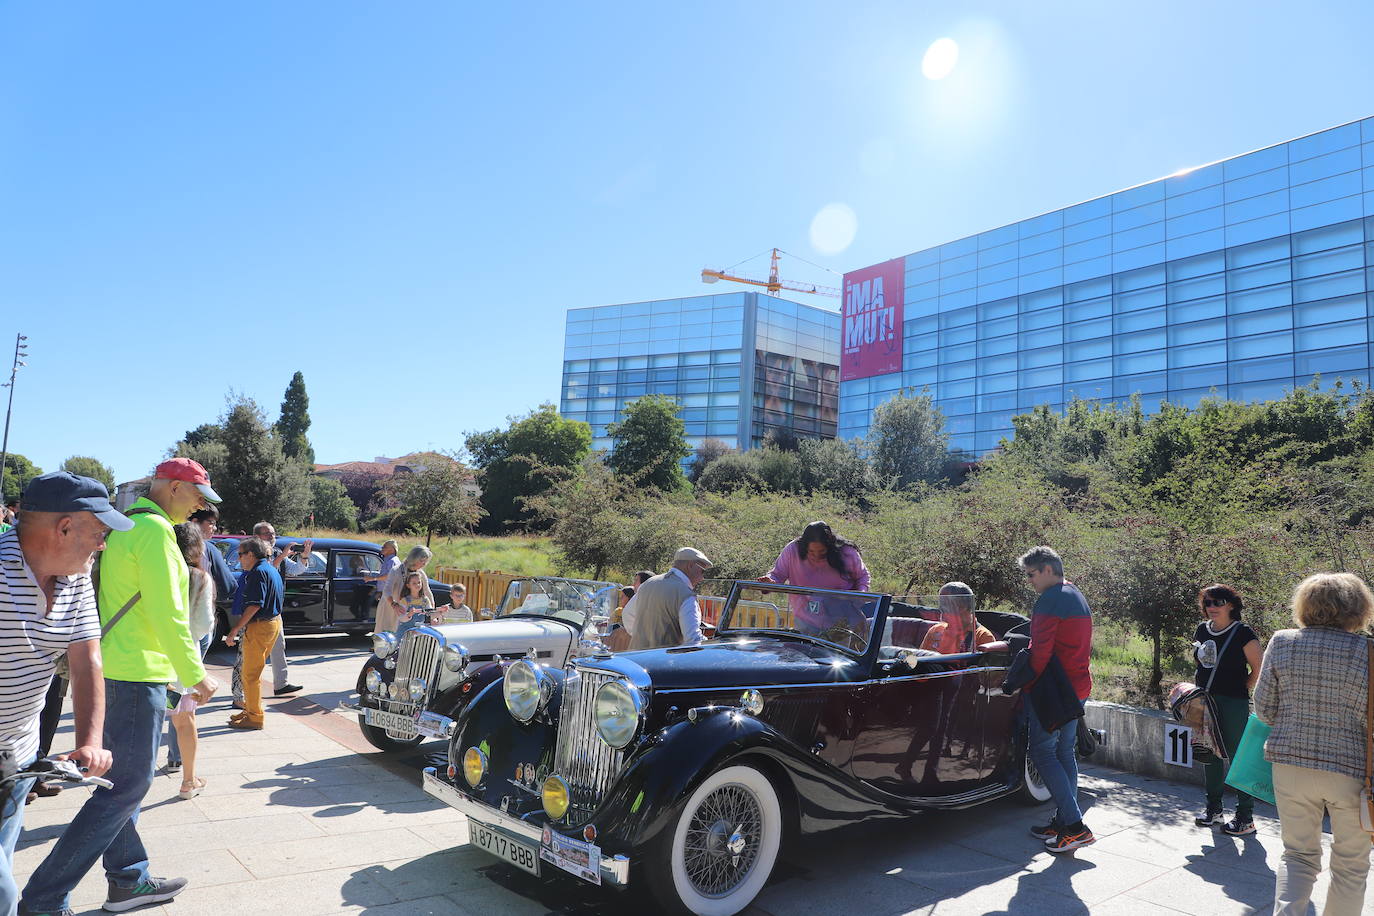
[344,577,621,750]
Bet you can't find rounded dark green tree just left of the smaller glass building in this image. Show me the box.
[466,404,592,534]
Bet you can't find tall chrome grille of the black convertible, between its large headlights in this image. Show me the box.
[554,667,625,824]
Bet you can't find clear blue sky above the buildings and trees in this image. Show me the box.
[0,0,1374,479]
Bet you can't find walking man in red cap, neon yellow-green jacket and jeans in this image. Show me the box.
[19,457,220,913]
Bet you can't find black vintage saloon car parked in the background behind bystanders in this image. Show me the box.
[210,536,449,639]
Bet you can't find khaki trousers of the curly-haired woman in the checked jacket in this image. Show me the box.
[1274,764,1370,916]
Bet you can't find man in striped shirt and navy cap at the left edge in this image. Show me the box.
[0,471,119,916]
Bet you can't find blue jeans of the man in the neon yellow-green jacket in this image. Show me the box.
[23,678,166,912]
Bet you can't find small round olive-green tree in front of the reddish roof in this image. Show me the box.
[379,452,482,544]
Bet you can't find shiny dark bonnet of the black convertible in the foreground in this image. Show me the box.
[585,636,864,691]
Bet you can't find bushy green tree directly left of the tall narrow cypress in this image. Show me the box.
[199,396,311,531]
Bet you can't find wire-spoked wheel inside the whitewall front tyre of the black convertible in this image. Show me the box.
[683,786,763,897]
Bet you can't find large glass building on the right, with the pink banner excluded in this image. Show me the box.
[840,118,1374,453]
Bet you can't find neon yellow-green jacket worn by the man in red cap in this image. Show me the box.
[99,499,205,685]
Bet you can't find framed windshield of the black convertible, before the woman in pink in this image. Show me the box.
[717,582,882,655]
